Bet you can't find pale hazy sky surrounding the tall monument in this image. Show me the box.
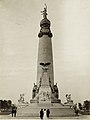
[0,0,90,103]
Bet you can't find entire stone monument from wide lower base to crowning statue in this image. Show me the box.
[17,5,74,117]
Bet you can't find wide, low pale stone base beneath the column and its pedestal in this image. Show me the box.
[17,103,75,117]
